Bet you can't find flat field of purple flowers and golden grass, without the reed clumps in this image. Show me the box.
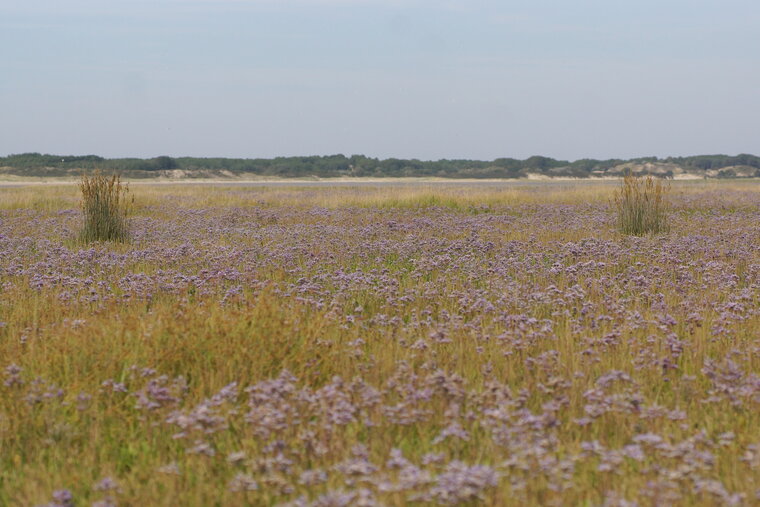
[0,181,760,507]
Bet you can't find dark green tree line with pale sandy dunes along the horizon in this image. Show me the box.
[0,153,760,178]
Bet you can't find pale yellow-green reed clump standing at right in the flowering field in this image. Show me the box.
[615,173,670,236]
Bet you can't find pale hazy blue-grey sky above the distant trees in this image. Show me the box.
[0,0,760,160]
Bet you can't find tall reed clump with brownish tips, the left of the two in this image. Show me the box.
[79,170,134,243]
